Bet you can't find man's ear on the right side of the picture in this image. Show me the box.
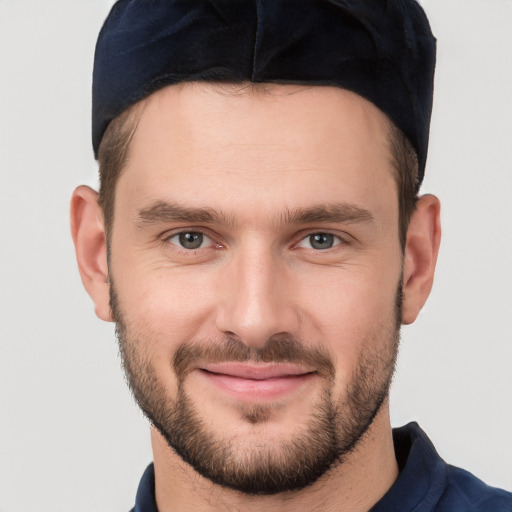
[402,195,441,324]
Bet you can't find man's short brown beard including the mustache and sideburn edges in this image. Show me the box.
[110,280,402,495]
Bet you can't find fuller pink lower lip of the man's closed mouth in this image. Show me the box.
[201,370,314,401]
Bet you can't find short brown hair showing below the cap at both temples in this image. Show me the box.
[98,93,418,251]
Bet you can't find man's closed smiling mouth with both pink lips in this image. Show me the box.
[198,363,316,402]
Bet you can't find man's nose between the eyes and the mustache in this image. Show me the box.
[216,243,299,348]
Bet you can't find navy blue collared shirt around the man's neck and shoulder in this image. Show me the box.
[132,423,512,512]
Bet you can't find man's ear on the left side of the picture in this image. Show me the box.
[71,186,112,322]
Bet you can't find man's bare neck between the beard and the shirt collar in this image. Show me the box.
[151,400,398,512]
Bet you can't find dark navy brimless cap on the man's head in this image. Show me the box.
[92,0,436,187]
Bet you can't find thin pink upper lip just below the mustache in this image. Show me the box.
[200,362,314,380]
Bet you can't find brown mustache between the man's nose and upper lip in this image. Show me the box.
[172,334,335,380]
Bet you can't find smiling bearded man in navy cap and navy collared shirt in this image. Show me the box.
[72,0,512,512]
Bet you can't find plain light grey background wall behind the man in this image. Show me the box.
[0,0,512,512]
